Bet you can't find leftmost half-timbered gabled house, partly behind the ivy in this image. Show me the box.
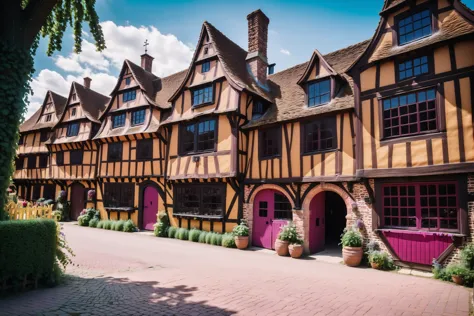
[13,91,66,201]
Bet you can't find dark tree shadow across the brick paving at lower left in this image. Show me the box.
[0,276,236,315]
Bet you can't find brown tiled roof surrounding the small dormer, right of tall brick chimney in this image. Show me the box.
[245,40,369,128]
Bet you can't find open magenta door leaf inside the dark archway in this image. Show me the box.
[309,192,326,253]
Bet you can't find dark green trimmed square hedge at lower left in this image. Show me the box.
[0,219,57,284]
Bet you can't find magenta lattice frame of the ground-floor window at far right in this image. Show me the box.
[380,181,461,232]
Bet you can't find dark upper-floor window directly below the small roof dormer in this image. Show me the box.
[302,117,336,154]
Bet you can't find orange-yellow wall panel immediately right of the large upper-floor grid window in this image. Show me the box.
[444,81,460,163]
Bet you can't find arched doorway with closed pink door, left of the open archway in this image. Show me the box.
[252,189,293,249]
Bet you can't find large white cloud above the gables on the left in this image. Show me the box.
[27,20,194,116]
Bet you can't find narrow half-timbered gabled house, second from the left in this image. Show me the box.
[46,77,109,219]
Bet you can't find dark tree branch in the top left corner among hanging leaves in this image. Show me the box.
[23,0,59,48]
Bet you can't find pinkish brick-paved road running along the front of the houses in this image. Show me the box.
[0,224,469,316]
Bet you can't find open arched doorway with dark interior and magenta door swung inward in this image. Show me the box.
[309,191,347,253]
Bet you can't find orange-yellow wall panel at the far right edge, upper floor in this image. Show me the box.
[459,76,474,161]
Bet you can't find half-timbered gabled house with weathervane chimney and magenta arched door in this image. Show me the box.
[94,53,184,230]
